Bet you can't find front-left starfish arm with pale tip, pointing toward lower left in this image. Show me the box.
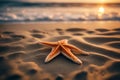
[45,45,60,62]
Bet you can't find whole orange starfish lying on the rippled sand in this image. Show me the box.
[40,39,89,64]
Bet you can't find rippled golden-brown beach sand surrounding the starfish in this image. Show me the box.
[0,22,120,80]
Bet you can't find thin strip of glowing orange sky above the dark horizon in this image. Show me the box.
[26,0,120,3]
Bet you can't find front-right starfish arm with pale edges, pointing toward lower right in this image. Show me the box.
[61,45,82,64]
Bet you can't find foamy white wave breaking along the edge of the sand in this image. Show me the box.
[0,13,120,23]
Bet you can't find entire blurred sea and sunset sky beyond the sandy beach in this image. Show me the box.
[0,0,120,23]
